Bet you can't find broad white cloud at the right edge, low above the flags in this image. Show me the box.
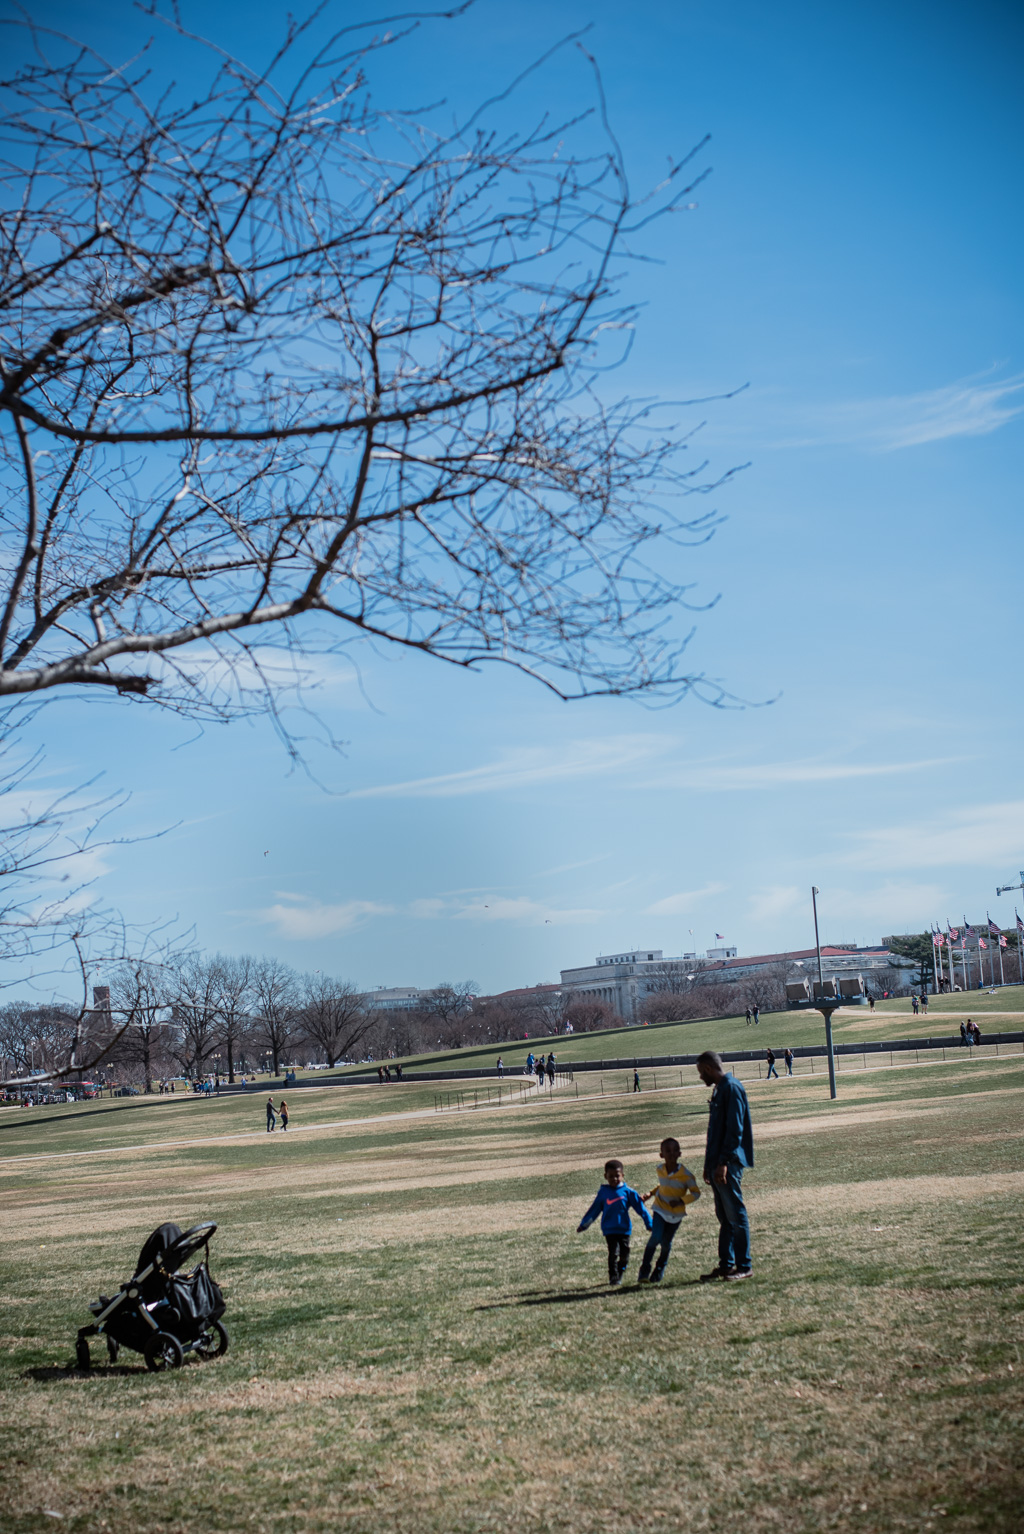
[845,799,1024,877]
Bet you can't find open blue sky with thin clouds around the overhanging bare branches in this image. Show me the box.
[18,0,1024,989]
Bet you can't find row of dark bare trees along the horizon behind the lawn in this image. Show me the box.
[0,953,907,1091]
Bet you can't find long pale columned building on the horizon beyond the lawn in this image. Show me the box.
[561,943,903,1023]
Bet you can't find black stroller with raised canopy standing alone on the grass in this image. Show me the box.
[75,1224,228,1374]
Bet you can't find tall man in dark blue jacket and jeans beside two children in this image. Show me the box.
[697,1049,754,1284]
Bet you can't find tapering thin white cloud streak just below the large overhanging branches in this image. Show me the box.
[348,735,668,799]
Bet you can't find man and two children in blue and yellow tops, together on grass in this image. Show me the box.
[576,1049,754,1289]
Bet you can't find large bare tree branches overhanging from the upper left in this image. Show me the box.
[0,9,735,730]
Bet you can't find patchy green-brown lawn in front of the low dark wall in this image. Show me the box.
[0,1055,1024,1534]
